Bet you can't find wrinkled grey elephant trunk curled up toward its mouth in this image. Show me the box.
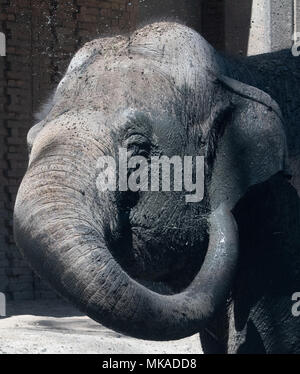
[14,124,238,340]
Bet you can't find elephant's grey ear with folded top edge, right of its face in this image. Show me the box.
[209,76,287,209]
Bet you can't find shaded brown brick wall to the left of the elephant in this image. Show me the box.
[0,0,137,299]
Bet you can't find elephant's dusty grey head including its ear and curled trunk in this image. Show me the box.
[14,22,286,340]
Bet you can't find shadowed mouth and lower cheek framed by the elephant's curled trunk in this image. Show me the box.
[107,196,209,294]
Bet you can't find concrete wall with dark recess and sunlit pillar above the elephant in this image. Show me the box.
[139,0,300,56]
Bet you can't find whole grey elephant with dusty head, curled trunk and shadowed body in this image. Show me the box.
[14,21,300,353]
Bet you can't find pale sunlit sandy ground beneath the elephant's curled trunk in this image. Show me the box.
[0,300,201,354]
